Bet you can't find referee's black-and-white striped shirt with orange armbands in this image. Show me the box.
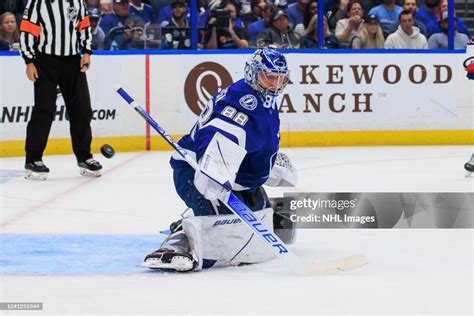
[20,0,92,64]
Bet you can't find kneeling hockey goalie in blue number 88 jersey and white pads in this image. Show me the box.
[143,48,297,272]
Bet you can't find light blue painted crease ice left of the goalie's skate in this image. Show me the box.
[0,234,164,276]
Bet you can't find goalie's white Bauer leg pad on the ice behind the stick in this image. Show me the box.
[183,208,275,270]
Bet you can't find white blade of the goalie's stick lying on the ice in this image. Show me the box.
[305,254,369,275]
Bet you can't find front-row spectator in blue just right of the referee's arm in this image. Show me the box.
[104,16,144,50]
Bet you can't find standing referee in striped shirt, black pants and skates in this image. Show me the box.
[20,0,102,180]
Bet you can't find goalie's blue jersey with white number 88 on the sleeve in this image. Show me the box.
[171,79,280,190]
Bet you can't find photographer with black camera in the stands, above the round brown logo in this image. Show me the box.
[204,0,249,49]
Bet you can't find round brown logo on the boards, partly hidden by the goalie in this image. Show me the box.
[184,62,233,115]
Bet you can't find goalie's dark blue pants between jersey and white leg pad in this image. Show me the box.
[173,165,271,216]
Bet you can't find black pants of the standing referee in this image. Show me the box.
[25,53,92,162]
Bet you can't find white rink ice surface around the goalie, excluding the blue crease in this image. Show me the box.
[0,146,474,315]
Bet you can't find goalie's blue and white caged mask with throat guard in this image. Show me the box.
[245,47,290,109]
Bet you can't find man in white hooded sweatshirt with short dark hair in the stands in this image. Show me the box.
[385,10,428,49]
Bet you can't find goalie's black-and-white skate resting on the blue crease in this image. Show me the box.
[139,248,197,272]
